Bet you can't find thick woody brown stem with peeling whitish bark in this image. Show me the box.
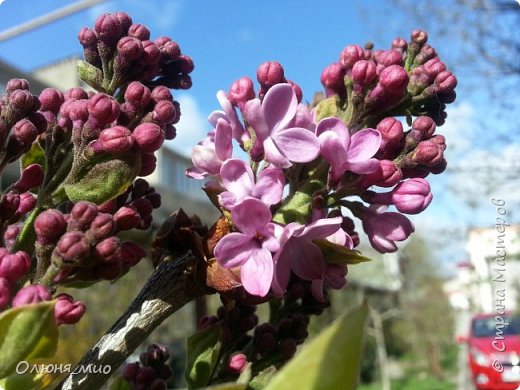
[61,252,207,390]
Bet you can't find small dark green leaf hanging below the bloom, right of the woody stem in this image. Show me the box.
[186,324,222,389]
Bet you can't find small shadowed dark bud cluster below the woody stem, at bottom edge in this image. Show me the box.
[123,344,172,390]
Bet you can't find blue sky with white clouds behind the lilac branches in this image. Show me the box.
[0,0,520,272]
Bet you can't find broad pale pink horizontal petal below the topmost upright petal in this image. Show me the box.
[272,127,320,162]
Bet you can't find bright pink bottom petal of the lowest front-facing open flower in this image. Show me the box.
[240,249,274,297]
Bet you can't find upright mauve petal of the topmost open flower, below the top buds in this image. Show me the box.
[262,84,298,135]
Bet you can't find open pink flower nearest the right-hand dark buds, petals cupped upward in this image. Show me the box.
[316,118,381,182]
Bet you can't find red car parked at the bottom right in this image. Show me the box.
[463,313,520,390]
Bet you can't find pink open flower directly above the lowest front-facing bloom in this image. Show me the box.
[219,158,285,210]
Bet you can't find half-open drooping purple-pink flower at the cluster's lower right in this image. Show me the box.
[363,205,415,253]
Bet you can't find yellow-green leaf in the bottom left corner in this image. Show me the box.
[0,301,58,378]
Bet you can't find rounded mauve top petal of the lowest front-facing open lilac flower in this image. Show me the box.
[231,197,272,237]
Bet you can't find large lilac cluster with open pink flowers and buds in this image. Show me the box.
[187,31,456,301]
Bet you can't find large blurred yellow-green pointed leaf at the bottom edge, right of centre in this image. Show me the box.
[265,304,368,390]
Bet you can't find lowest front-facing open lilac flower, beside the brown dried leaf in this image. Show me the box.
[214,198,281,296]
